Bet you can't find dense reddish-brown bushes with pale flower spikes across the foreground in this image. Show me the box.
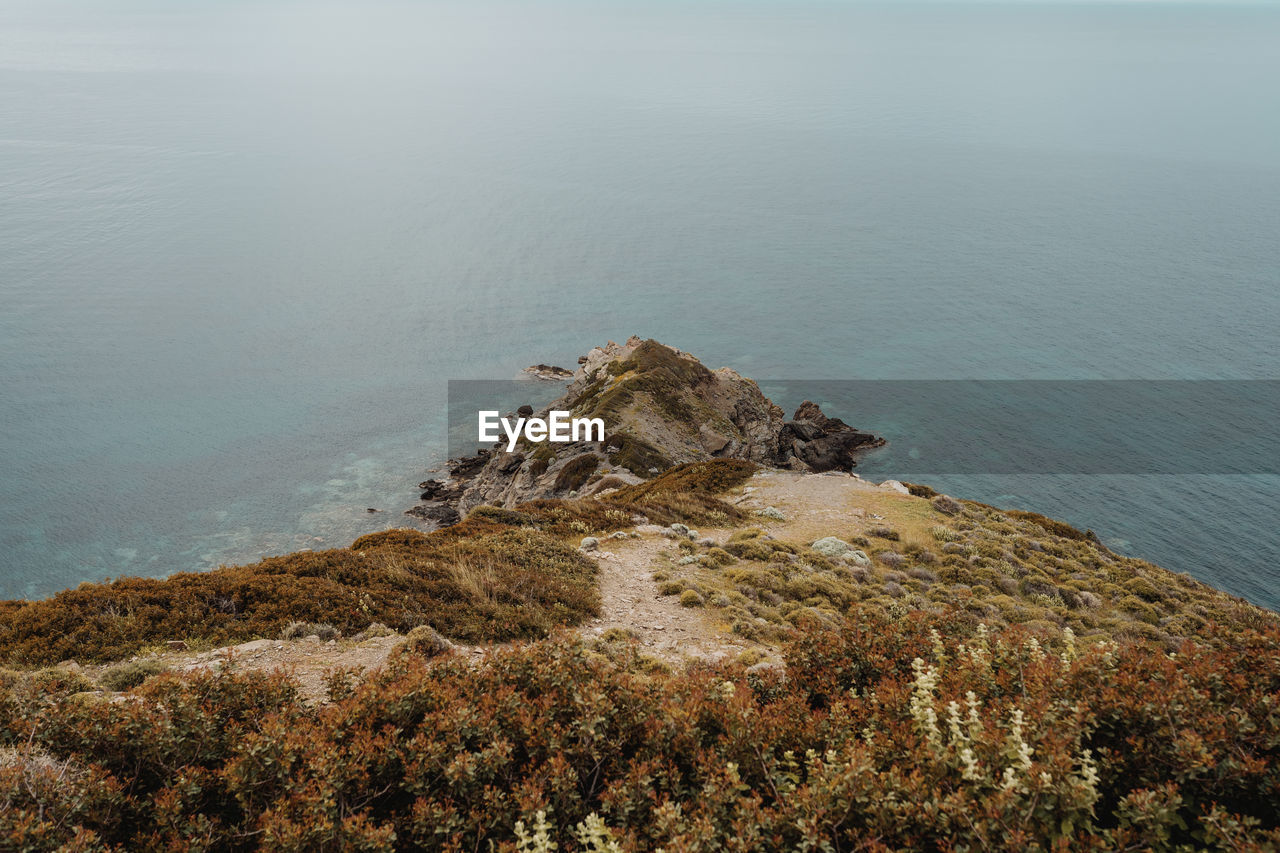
[0,612,1280,853]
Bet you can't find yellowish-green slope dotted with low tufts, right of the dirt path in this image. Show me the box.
[655,480,1277,649]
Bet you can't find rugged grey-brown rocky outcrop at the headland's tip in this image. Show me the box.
[408,338,884,525]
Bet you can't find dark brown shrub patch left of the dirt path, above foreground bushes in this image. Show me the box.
[0,521,599,665]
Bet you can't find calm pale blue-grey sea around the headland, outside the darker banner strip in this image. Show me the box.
[0,0,1280,607]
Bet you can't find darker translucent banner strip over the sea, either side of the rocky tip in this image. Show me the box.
[448,379,1280,478]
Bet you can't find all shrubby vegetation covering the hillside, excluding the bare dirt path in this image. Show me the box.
[0,460,1280,852]
